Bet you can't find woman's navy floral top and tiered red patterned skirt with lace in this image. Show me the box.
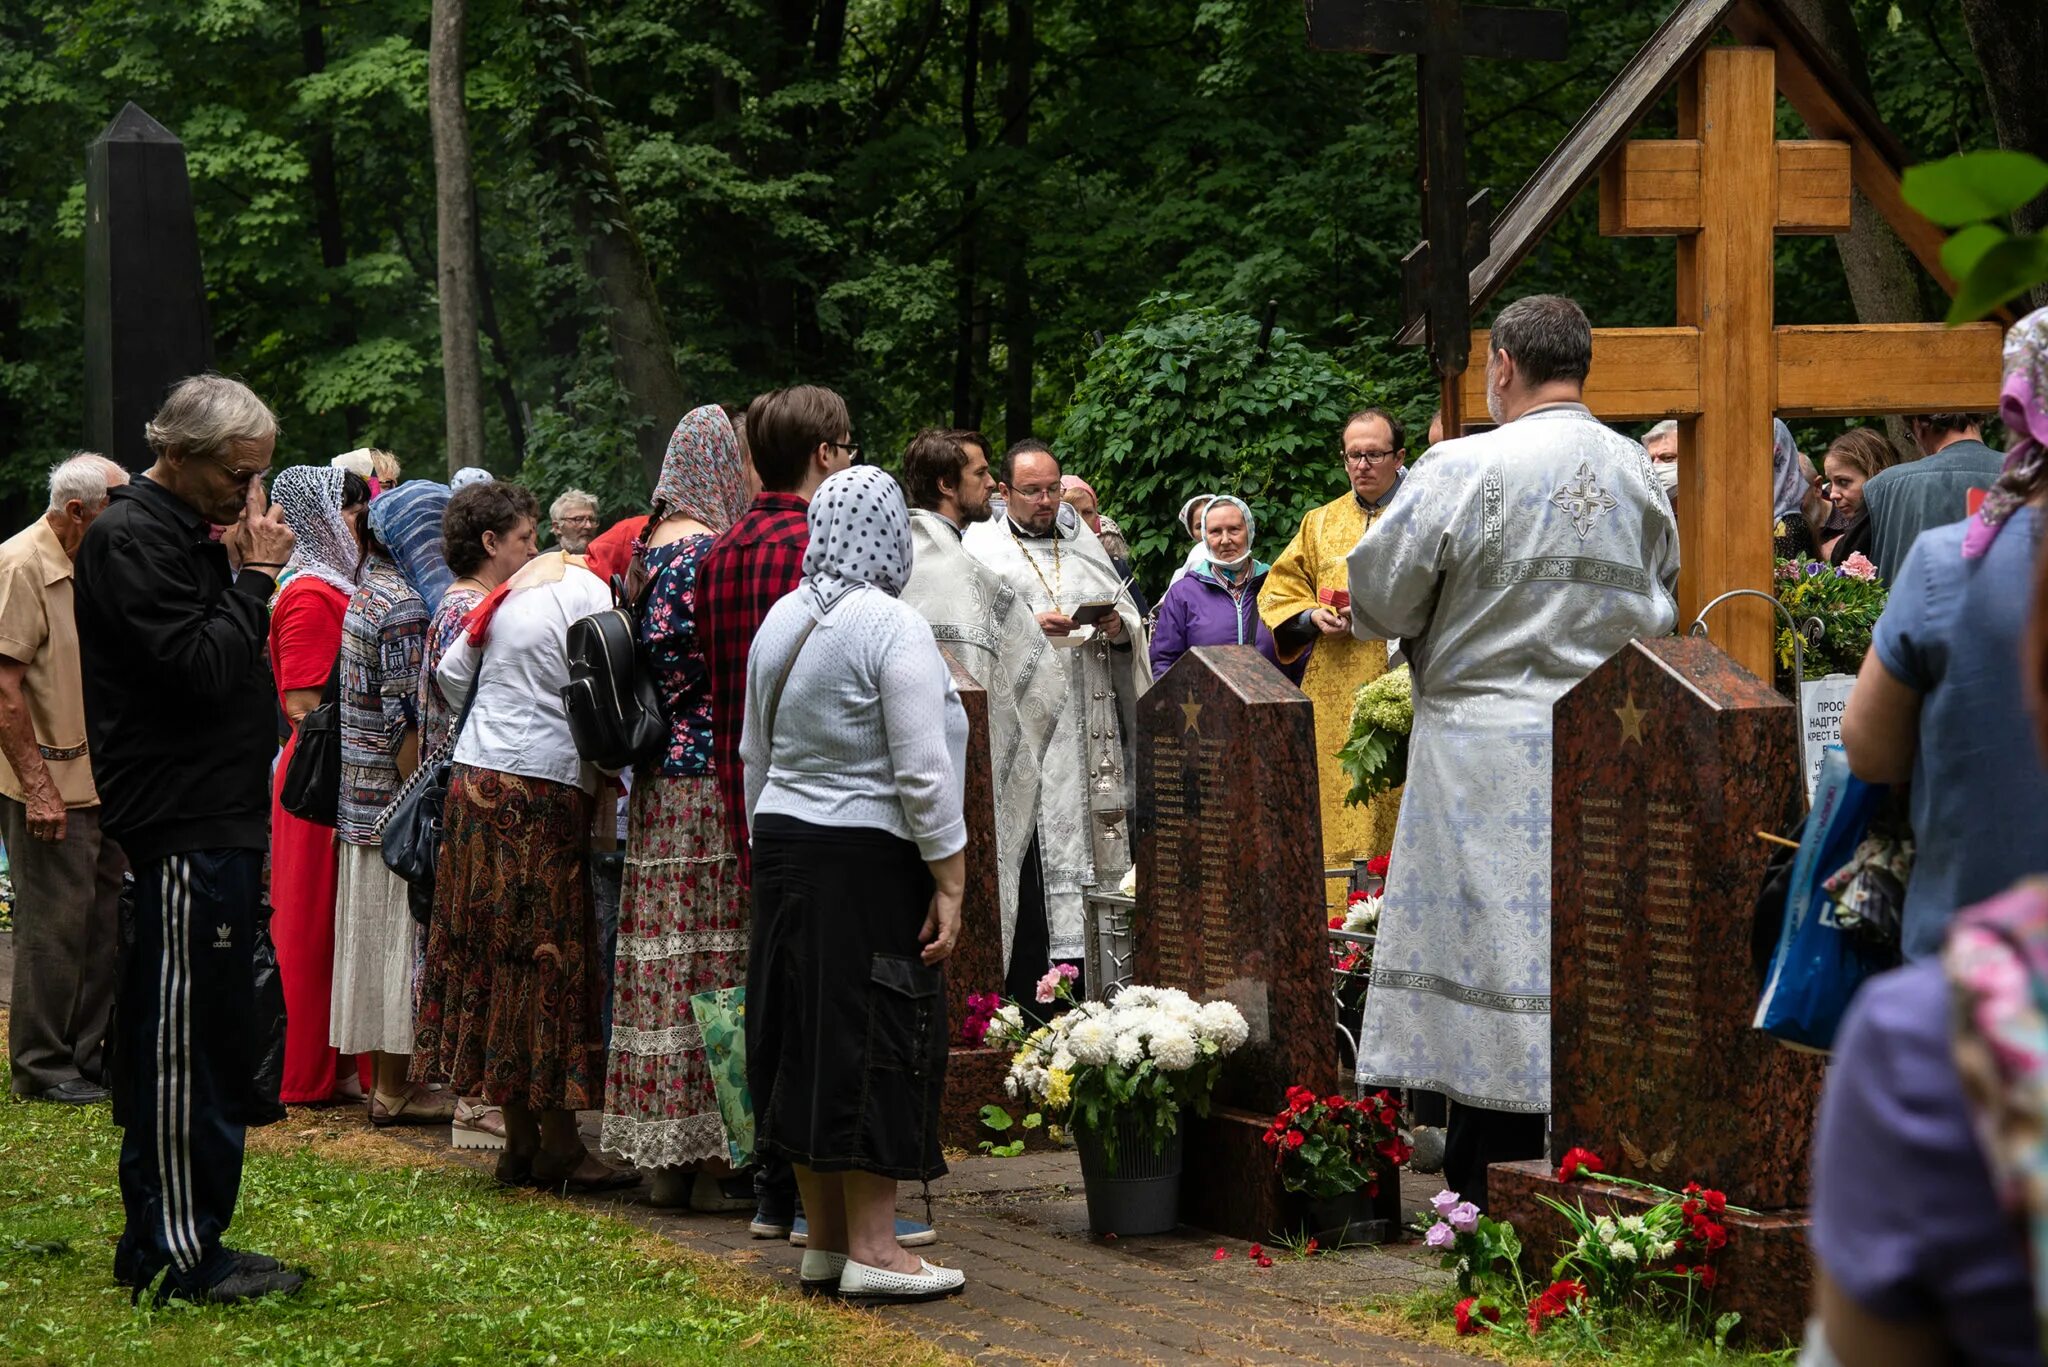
[602,535,748,1168]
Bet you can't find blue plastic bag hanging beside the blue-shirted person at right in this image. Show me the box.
[1753,746,1886,1053]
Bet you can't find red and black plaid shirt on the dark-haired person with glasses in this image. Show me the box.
[696,490,811,887]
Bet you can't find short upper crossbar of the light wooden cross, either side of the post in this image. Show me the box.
[1599,137,1853,238]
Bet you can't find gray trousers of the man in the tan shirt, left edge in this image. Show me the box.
[0,797,127,1096]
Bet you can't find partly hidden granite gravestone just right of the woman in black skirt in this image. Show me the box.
[940,648,1042,1150]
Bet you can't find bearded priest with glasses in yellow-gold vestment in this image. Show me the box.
[1260,408,1407,869]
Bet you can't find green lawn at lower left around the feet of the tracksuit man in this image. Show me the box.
[0,1065,948,1367]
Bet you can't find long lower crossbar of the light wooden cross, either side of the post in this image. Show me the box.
[1462,324,2003,422]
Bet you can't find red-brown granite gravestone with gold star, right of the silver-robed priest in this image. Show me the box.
[1489,637,1821,1332]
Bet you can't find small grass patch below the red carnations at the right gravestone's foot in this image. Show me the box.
[1352,1289,1798,1367]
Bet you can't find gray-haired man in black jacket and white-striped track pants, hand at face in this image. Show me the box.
[76,375,305,1303]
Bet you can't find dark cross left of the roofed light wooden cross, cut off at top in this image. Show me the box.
[1305,0,1567,437]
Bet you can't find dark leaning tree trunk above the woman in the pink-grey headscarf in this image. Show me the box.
[524,0,684,480]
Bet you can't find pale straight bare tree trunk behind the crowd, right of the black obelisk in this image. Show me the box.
[426,0,483,475]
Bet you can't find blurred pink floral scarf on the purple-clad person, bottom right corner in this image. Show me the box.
[1942,881,2048,1342]
